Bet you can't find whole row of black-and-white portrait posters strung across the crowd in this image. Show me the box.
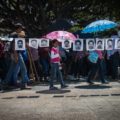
[2,38,120,51]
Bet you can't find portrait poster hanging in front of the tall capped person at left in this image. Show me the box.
[15,38,25,50]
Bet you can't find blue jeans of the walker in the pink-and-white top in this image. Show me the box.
[50,63,64,87]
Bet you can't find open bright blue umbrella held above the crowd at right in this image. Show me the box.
[82,20,117,33]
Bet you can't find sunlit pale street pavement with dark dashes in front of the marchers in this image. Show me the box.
[0,81,120,120]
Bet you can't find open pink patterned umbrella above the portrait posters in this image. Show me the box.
[45,31,76,42]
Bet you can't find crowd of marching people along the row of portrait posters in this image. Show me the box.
[0,24,120,90]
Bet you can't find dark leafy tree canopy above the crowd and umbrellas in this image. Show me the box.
[0,0,120,37]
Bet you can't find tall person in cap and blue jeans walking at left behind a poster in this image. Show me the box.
[5,24,29,89]
